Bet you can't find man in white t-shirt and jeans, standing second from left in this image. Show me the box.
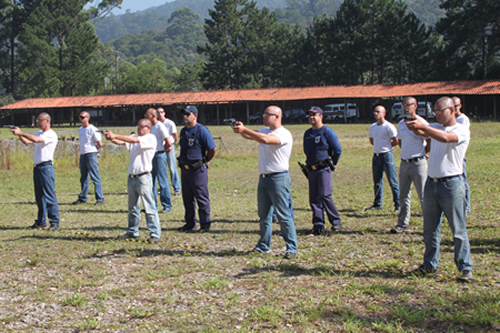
[73,111,104,205]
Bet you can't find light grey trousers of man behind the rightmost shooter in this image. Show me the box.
[398,158,427,228]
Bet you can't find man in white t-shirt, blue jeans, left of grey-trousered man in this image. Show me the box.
[366,105,399,212]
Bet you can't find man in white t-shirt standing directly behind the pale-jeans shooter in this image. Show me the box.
[144,108,172,214]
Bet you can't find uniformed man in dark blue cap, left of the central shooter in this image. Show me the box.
[178,105,216,232]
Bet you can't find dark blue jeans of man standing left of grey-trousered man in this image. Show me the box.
[372,151,399,207]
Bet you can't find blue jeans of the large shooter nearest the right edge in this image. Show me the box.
[423,175,473,272]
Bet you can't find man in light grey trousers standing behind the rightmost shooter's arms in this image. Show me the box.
[391,97,430,234]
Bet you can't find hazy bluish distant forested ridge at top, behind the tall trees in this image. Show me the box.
[95,0,444,42]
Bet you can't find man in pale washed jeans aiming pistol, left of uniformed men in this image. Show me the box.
[105,119,161,243]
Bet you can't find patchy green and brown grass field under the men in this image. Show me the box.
[0,123,500,332]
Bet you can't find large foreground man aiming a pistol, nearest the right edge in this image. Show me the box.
[407,97,473,281]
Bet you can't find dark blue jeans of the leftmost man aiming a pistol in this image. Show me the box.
[33,164,59,226]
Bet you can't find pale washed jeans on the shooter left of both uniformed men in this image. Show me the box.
[127,173,161,238]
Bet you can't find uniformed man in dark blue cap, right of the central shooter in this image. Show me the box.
[304,106,342,235]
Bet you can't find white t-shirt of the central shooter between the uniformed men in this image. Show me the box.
[258,126,293,174]
